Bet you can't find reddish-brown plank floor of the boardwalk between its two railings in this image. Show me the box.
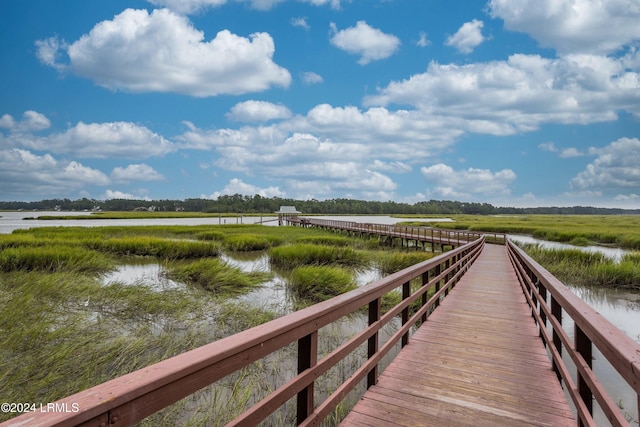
[341,245,576,427]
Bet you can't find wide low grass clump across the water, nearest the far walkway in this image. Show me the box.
[269,243,368,268]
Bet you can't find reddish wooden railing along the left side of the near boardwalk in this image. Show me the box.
[1,237,484,427]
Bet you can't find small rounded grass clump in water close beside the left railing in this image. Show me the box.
[289,265,357,303]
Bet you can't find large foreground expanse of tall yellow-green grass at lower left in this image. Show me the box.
[0,272,274,425]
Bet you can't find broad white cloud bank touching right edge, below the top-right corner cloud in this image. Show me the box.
[364,54,640,135]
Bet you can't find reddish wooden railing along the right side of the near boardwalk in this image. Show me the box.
[507,241,640,426]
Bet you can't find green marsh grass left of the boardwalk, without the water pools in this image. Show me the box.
[0,225,452,426]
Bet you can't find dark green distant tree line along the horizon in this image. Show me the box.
[0,194,640,215]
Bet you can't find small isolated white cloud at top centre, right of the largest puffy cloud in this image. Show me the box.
[331,21,400,65]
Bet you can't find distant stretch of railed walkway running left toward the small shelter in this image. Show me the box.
[287,217,505,246]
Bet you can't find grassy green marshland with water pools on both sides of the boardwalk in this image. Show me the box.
[0,215,640,425]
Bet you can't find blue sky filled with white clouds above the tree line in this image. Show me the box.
[0,0,640,208]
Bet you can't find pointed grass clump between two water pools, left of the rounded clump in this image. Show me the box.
[167,258,271,297]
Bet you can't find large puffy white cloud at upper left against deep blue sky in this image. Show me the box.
[37,9,291,97]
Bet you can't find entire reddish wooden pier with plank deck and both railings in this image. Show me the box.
[2,223,640,426]
